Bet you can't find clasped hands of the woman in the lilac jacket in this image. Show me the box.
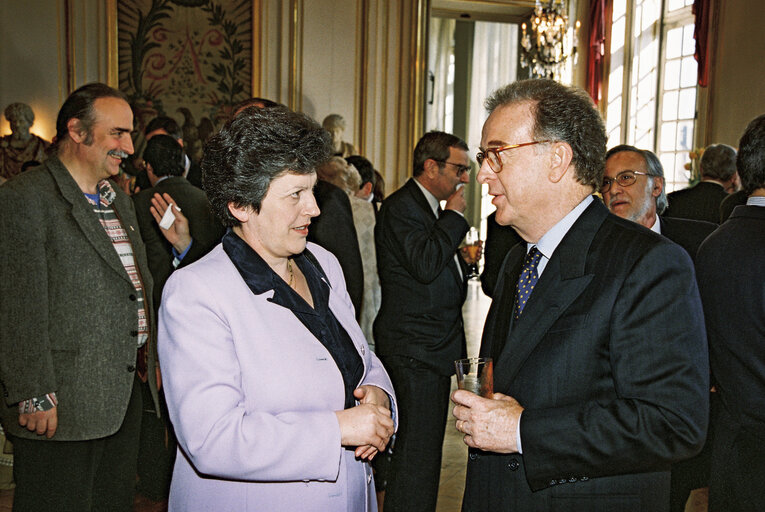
[335,385,394,460]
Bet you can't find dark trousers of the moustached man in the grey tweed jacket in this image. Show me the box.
[11,378,142,512]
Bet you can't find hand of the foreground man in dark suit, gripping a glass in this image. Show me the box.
[452,389,523,453]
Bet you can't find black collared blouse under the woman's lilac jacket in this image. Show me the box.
[223,229,364,409]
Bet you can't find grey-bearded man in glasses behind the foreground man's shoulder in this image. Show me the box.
[600,144,717,512]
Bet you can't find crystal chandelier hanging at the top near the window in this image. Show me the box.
[521,0,579,80]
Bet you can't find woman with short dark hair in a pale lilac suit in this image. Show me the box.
[158,107,395,512]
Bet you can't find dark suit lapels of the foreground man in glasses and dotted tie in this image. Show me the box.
[494,200,608,392]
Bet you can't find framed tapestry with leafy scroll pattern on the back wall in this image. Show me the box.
[117,0,252,159]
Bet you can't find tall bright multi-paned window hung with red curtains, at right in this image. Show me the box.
[606,0,697,192]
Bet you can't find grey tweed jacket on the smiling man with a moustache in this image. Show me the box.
[0,157,156,441]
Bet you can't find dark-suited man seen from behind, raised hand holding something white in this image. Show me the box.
[133,134,224,501]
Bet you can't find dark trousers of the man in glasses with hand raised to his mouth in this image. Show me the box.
[382,356,451,512]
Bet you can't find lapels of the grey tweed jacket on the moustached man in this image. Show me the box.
[48,157,137,282]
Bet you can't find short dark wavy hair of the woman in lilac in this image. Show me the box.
[201,107,332,226]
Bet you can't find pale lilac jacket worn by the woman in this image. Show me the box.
[158,243,397,512]
